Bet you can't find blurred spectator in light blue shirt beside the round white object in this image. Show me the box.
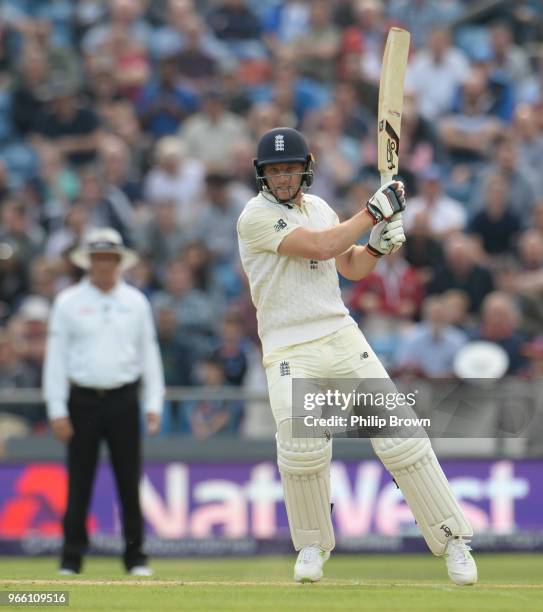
[395,297,468,378]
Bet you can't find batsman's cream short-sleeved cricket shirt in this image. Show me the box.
[237,194,355,355]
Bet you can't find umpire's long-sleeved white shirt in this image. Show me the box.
[43,278,164,419]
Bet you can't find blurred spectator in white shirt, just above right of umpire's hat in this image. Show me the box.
[144,136,204,226]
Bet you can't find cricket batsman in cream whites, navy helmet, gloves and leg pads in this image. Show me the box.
[237,127,477,585]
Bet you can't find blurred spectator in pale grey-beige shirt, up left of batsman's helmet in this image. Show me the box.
[179,91,247,167]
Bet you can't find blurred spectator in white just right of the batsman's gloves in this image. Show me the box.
[403,165,467,239]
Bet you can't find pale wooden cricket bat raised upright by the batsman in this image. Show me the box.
[377,28,411,225]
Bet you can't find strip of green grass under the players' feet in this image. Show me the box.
[0,555,543,612]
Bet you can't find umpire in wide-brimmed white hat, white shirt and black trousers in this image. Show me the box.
[44,228,164,576]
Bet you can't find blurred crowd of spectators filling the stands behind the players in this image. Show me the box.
[0,0,543,438]
